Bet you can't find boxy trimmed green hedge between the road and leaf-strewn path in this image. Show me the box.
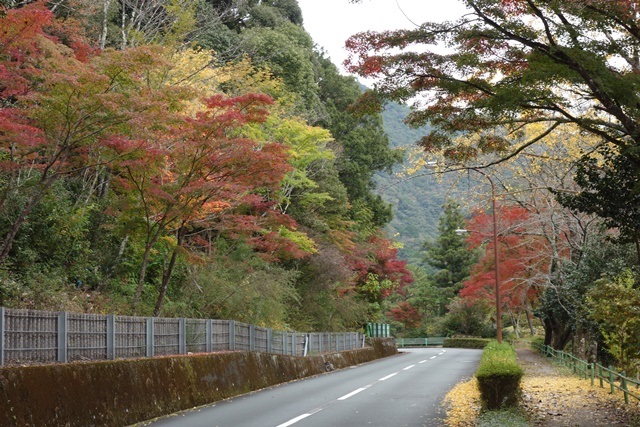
[476,341,524,410]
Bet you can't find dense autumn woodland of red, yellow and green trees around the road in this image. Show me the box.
[0,0,640,371]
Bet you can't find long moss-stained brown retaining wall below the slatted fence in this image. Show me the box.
[0,338,397,427]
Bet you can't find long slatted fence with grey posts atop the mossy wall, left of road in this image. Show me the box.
[0,307,364,366]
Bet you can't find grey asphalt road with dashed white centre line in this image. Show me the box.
[142,348,482,427]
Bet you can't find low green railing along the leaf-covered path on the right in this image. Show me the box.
[534,345,640,403]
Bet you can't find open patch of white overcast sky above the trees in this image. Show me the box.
[298,0,465,72]
